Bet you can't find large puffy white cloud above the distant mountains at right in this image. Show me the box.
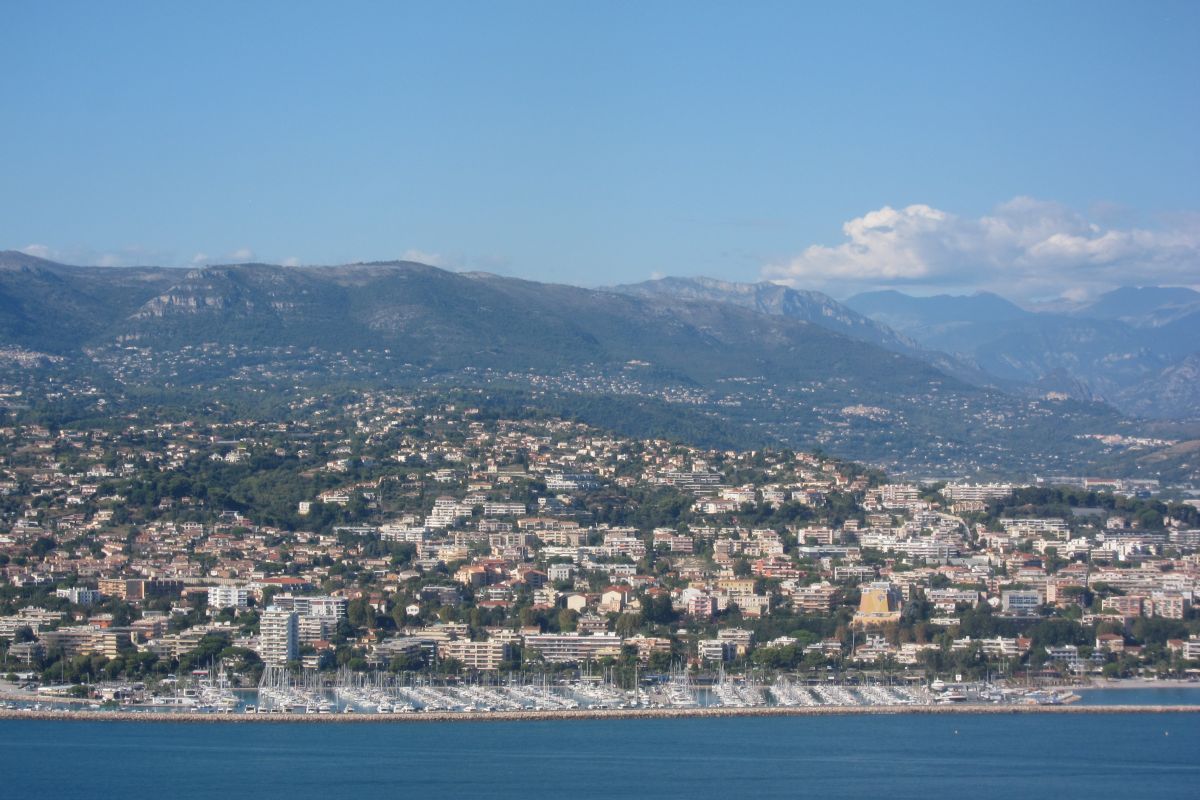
[763,197,1200,297]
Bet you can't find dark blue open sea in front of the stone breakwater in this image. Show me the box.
[0,714,1200,800]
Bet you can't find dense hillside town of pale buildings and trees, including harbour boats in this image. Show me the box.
[0,391,1200,712]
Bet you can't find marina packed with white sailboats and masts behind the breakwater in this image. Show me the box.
[0,667,1113,718]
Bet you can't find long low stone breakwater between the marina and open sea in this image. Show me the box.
[0,704,1200,724]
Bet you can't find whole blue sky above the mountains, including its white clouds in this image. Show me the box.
[0,1,1200,297]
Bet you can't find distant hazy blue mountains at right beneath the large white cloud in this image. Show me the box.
[616,278,1200,419]
